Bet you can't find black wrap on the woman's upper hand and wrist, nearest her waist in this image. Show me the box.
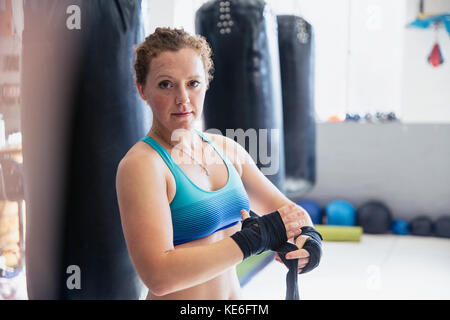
[231,211,287,259]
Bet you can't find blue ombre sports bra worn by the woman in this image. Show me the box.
[141,130,250,245]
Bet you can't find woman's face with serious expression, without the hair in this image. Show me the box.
[138,48,207,131]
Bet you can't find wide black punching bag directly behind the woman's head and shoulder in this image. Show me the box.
[195,0,285,191]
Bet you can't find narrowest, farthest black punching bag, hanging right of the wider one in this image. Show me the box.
[277,15,316,199]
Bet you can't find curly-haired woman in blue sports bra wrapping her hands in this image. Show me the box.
[117,28,312,299]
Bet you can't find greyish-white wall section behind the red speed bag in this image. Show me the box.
[401,0,450,123]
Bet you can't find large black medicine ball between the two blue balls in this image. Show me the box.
[357,201,392,234]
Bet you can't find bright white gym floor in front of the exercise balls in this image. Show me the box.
[243,234,450,300]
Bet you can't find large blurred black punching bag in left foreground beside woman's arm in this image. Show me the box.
[21,0,151,299]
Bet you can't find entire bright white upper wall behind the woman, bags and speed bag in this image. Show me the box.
[143,0,450,123]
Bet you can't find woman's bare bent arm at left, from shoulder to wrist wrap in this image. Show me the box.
[116,155,243,296]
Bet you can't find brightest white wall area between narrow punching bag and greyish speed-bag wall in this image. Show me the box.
[268,0,405,120]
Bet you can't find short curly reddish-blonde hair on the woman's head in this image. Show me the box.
[134,28,214,86]
